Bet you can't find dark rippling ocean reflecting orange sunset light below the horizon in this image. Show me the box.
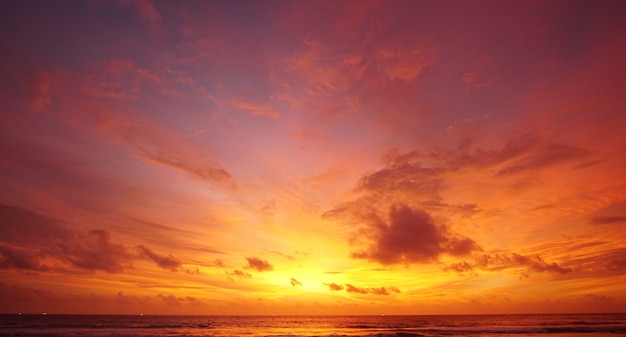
[0,314,626,337]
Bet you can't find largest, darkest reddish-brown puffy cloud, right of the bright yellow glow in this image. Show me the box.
[352,205,480,265]
